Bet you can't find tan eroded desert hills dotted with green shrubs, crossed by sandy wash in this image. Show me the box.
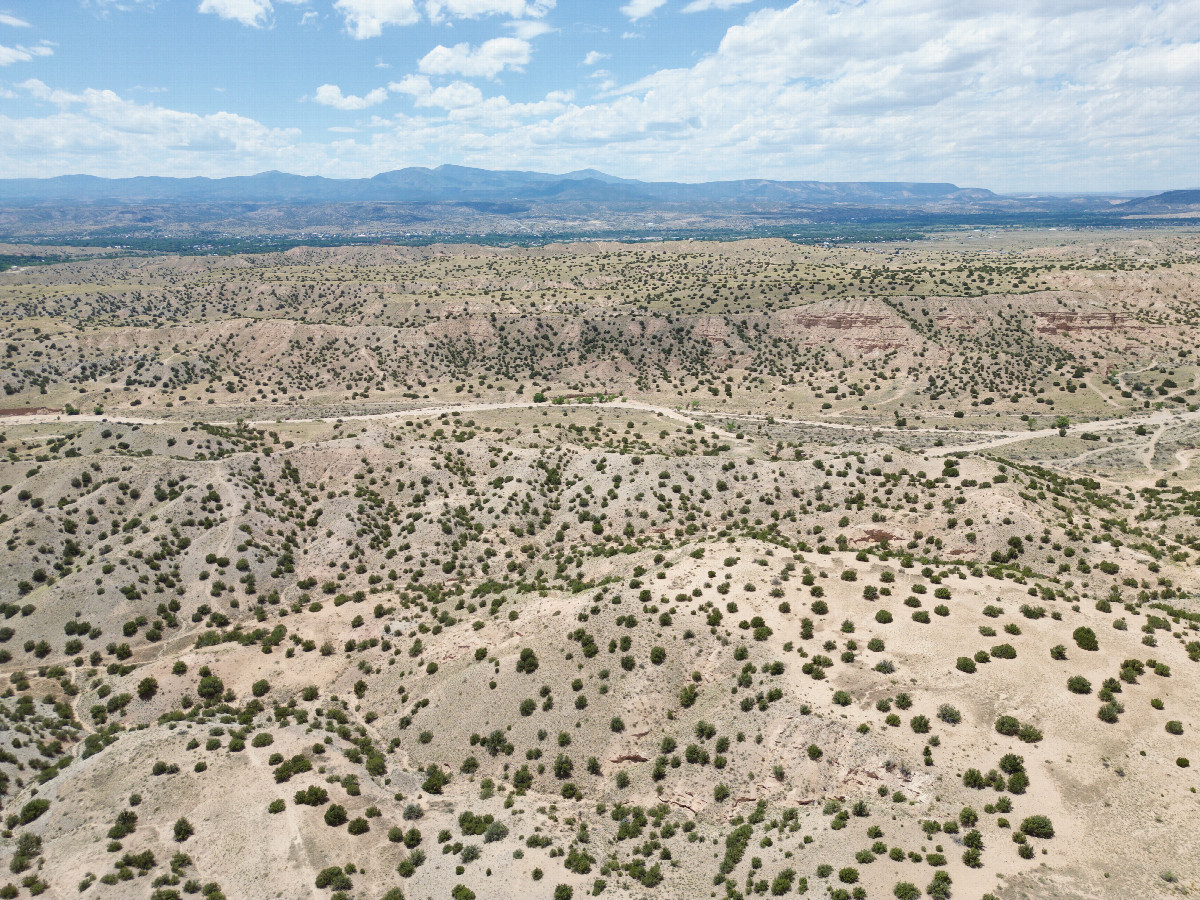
[0,233,1200,900]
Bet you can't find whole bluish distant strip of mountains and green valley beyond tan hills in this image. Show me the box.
[0,166,1185,246]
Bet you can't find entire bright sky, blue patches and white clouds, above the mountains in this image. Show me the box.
[0,0,1200,191]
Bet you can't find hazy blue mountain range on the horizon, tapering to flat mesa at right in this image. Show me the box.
[0,166,998,206]
